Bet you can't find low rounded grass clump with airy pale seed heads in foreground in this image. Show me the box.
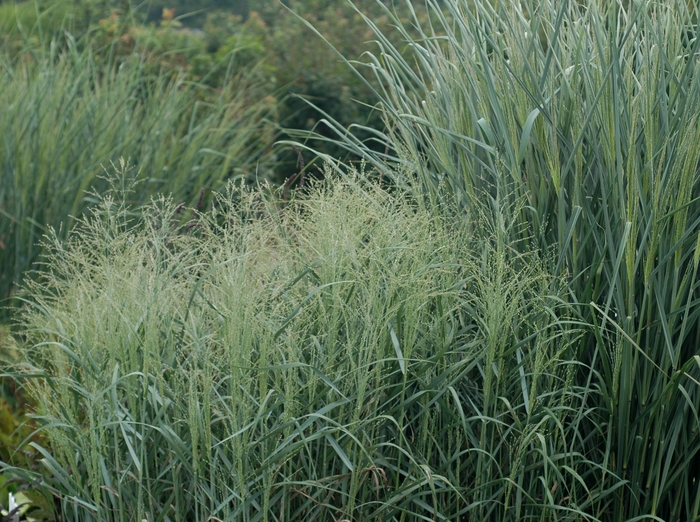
[5,167,600,521]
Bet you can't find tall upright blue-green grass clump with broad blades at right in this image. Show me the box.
[298,0,700,521]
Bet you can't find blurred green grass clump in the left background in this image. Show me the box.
[0,40,274,312]
